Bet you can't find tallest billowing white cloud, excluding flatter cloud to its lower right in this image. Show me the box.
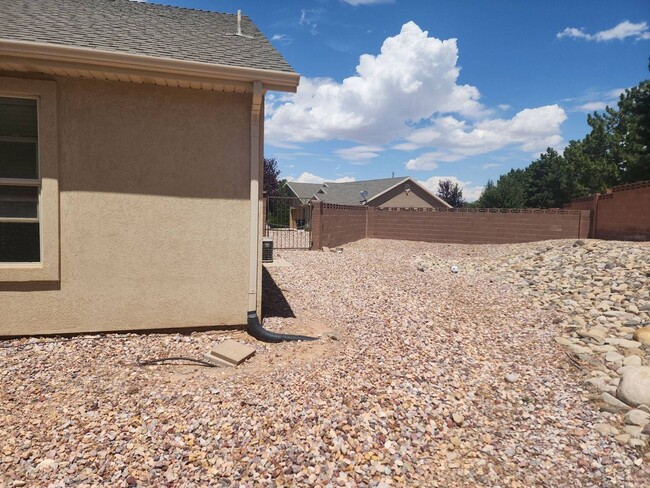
[266,22,485,144]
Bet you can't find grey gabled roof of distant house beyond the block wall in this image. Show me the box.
[287,176,449,207]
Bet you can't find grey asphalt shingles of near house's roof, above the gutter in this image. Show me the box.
[0,0,294,73]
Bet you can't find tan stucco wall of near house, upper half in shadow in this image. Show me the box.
[0,78,251,335]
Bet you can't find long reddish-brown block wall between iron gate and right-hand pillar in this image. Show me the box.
[312,203,591,249]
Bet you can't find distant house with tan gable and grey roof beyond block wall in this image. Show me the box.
[287,176,451,208]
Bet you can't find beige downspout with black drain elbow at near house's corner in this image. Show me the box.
[246,81,316,342]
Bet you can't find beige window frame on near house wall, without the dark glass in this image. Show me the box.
[0,76,60,282]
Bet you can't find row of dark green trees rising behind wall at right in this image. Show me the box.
[476,73,650,208]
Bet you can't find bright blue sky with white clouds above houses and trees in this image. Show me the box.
[144,0,650,200]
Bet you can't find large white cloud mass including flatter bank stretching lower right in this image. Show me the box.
[266,22,564,170]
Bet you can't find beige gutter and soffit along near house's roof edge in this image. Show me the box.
[0,39,300,92]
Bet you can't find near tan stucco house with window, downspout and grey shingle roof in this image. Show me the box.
[0,0,299,336]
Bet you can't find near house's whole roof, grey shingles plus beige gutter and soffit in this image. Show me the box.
[0,0,300,93]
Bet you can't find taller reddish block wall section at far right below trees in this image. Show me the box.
[595,181,650,241]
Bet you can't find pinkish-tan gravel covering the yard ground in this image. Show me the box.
[0,240,650,487]
